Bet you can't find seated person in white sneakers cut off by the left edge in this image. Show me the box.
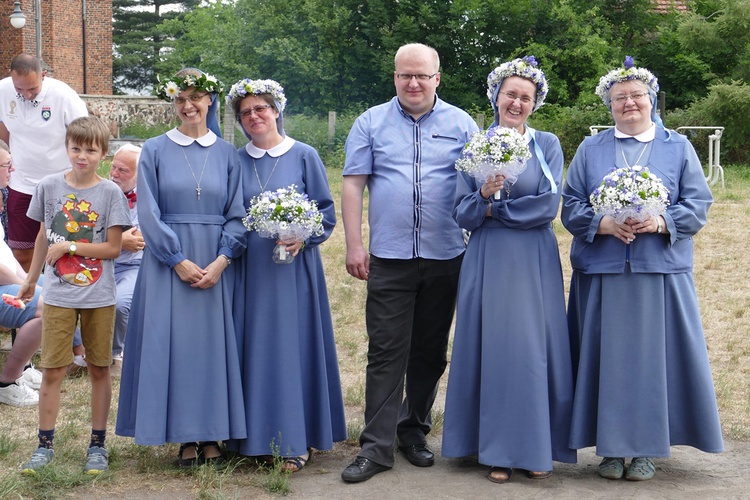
[0,141,42,406]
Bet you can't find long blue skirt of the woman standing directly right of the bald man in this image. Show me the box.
[442,227,576,471]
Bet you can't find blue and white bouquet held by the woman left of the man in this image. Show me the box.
[242,184,323,241]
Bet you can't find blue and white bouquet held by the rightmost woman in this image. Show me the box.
[589,165,669,224]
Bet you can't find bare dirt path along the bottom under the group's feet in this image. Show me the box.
[91,441,750,500]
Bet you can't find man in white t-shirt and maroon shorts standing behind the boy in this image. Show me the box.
[0,54,88,270]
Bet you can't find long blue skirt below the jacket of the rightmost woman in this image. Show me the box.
[568,271,724,457]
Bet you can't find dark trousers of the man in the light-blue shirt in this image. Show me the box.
[359,255,463,466]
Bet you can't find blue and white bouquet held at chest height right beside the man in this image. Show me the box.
[456,127,531,198]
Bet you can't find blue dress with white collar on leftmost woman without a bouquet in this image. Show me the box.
[116,130,246,445]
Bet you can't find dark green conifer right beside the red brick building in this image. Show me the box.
[112,0,200,93]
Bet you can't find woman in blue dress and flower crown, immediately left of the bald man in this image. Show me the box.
[227,79,346,472]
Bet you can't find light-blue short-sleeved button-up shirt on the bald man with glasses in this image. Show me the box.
[343,97,479,260]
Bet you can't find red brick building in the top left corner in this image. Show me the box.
[0,0,112,95]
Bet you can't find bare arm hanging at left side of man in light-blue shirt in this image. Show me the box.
[341,175,370,280]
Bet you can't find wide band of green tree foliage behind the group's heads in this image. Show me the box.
[114,0,750,160]
